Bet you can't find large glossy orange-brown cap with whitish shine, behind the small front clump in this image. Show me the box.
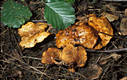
[56,24,98,48]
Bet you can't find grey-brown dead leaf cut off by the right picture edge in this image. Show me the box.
[120,18,127,35]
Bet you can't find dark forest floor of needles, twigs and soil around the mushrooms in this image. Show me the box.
[0,0,127,80]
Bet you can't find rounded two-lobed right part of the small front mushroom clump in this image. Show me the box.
[60,45,87,67]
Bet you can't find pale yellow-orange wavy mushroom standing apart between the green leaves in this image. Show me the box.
[18,22,50,48]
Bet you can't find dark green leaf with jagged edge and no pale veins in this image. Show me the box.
[1,0,32,28]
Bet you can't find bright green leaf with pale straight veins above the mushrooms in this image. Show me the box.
[44,1,75,29]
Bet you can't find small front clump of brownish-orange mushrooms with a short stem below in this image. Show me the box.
[41,45,87,72]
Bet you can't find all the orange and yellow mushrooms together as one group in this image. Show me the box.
[18,14,113,72]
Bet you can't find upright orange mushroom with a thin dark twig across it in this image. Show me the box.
[88,14,113,49]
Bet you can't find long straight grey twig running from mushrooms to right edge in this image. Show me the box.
[86,48,127,53]
